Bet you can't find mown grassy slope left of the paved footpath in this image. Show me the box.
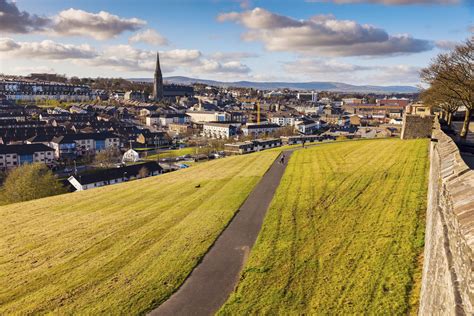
[0,152,278,315]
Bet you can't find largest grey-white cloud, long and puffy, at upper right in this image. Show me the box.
[217,8,432,56]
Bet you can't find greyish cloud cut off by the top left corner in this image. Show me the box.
[0,0,51,33]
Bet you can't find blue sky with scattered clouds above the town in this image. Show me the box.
[0,0,474,85]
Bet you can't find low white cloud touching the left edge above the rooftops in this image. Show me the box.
[0,38,97,60]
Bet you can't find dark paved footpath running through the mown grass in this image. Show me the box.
[151,151,291,315]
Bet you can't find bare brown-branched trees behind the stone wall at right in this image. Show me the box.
[421,37,474,138]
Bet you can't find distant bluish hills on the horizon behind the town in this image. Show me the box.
[129,76,419,93]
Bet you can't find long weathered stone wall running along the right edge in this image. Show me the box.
[419,122,474,315]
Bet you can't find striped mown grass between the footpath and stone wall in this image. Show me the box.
[220,139,429,315]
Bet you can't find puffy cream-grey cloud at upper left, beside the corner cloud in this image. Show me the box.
[53,8,146,40]
